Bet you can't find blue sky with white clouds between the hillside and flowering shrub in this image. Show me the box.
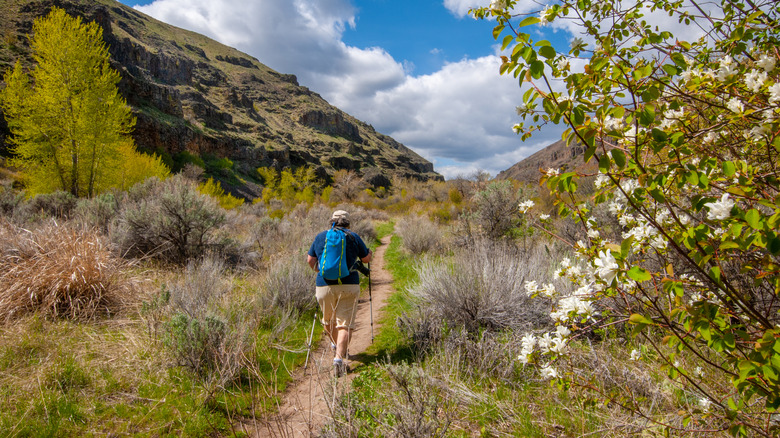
[116,0,571,178]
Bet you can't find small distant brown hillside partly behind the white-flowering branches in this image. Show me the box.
[496,140,597,185]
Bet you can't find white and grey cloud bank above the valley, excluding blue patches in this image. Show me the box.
[136,0,560,177]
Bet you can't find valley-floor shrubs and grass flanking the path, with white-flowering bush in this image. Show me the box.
[0,0,780,436]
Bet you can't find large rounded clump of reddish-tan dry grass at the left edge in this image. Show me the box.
[0,220,132,320]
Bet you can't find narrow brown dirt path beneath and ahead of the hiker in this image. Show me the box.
[247,236,392,438]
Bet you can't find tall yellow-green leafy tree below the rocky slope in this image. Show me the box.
[0,8,167,197]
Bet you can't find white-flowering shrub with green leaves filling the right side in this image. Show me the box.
[472,0,780,436]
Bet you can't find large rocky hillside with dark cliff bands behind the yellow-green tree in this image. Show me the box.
[0,0,441,197]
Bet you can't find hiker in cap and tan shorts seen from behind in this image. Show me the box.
[307,210,372,377]
